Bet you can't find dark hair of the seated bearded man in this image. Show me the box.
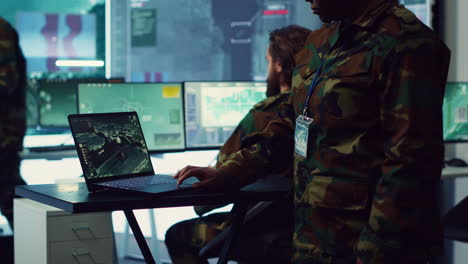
[269,25,311,86]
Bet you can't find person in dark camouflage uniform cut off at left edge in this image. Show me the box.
[0,18,26,227]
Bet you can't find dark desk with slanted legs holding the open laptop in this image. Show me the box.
[16,177,291,263]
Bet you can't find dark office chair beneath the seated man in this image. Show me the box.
[199,199,293,263]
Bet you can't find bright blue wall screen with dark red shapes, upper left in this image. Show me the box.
[16,11,99,74]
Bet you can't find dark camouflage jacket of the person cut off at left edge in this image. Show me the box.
[0,18,26,151]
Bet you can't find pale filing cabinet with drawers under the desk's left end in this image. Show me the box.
[14,198,114,264]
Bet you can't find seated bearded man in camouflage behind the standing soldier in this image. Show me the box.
[165,26,310,264]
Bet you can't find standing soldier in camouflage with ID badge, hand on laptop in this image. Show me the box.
[175,0,450,264]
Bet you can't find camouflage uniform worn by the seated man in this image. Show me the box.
[165,92,292,264]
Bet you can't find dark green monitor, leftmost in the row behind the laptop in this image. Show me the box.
[38,79,114,128]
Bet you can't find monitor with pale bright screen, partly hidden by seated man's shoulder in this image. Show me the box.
[184,82,266,149]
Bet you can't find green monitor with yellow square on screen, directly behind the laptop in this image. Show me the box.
[78,83,185,152]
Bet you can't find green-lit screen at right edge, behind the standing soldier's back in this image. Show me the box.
[443,83,468,141]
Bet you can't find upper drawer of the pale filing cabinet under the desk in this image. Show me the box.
[47,213,113,242]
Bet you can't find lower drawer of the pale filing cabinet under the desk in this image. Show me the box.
[48,238,114,264]
